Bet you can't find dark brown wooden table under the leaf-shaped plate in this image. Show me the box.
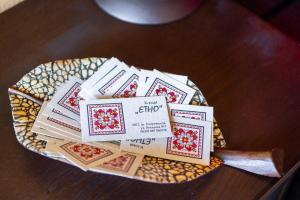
[0,0,300,199]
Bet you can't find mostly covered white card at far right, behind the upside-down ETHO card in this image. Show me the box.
[168,103,214,152]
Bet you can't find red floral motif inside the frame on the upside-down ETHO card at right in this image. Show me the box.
[173,128,197,152]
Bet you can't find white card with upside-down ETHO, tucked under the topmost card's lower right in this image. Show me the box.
[121,117,211,165]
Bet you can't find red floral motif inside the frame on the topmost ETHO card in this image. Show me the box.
[94,108,120,130]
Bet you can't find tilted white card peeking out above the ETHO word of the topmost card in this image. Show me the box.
[136,70,196,104]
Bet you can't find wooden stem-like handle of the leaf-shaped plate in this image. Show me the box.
[214,148,283,177]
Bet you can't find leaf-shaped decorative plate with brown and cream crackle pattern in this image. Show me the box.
[9,58,226,183]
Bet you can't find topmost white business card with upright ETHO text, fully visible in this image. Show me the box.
[80,97,172,142]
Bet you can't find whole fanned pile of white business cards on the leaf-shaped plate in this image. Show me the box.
[31,58,213,177]
